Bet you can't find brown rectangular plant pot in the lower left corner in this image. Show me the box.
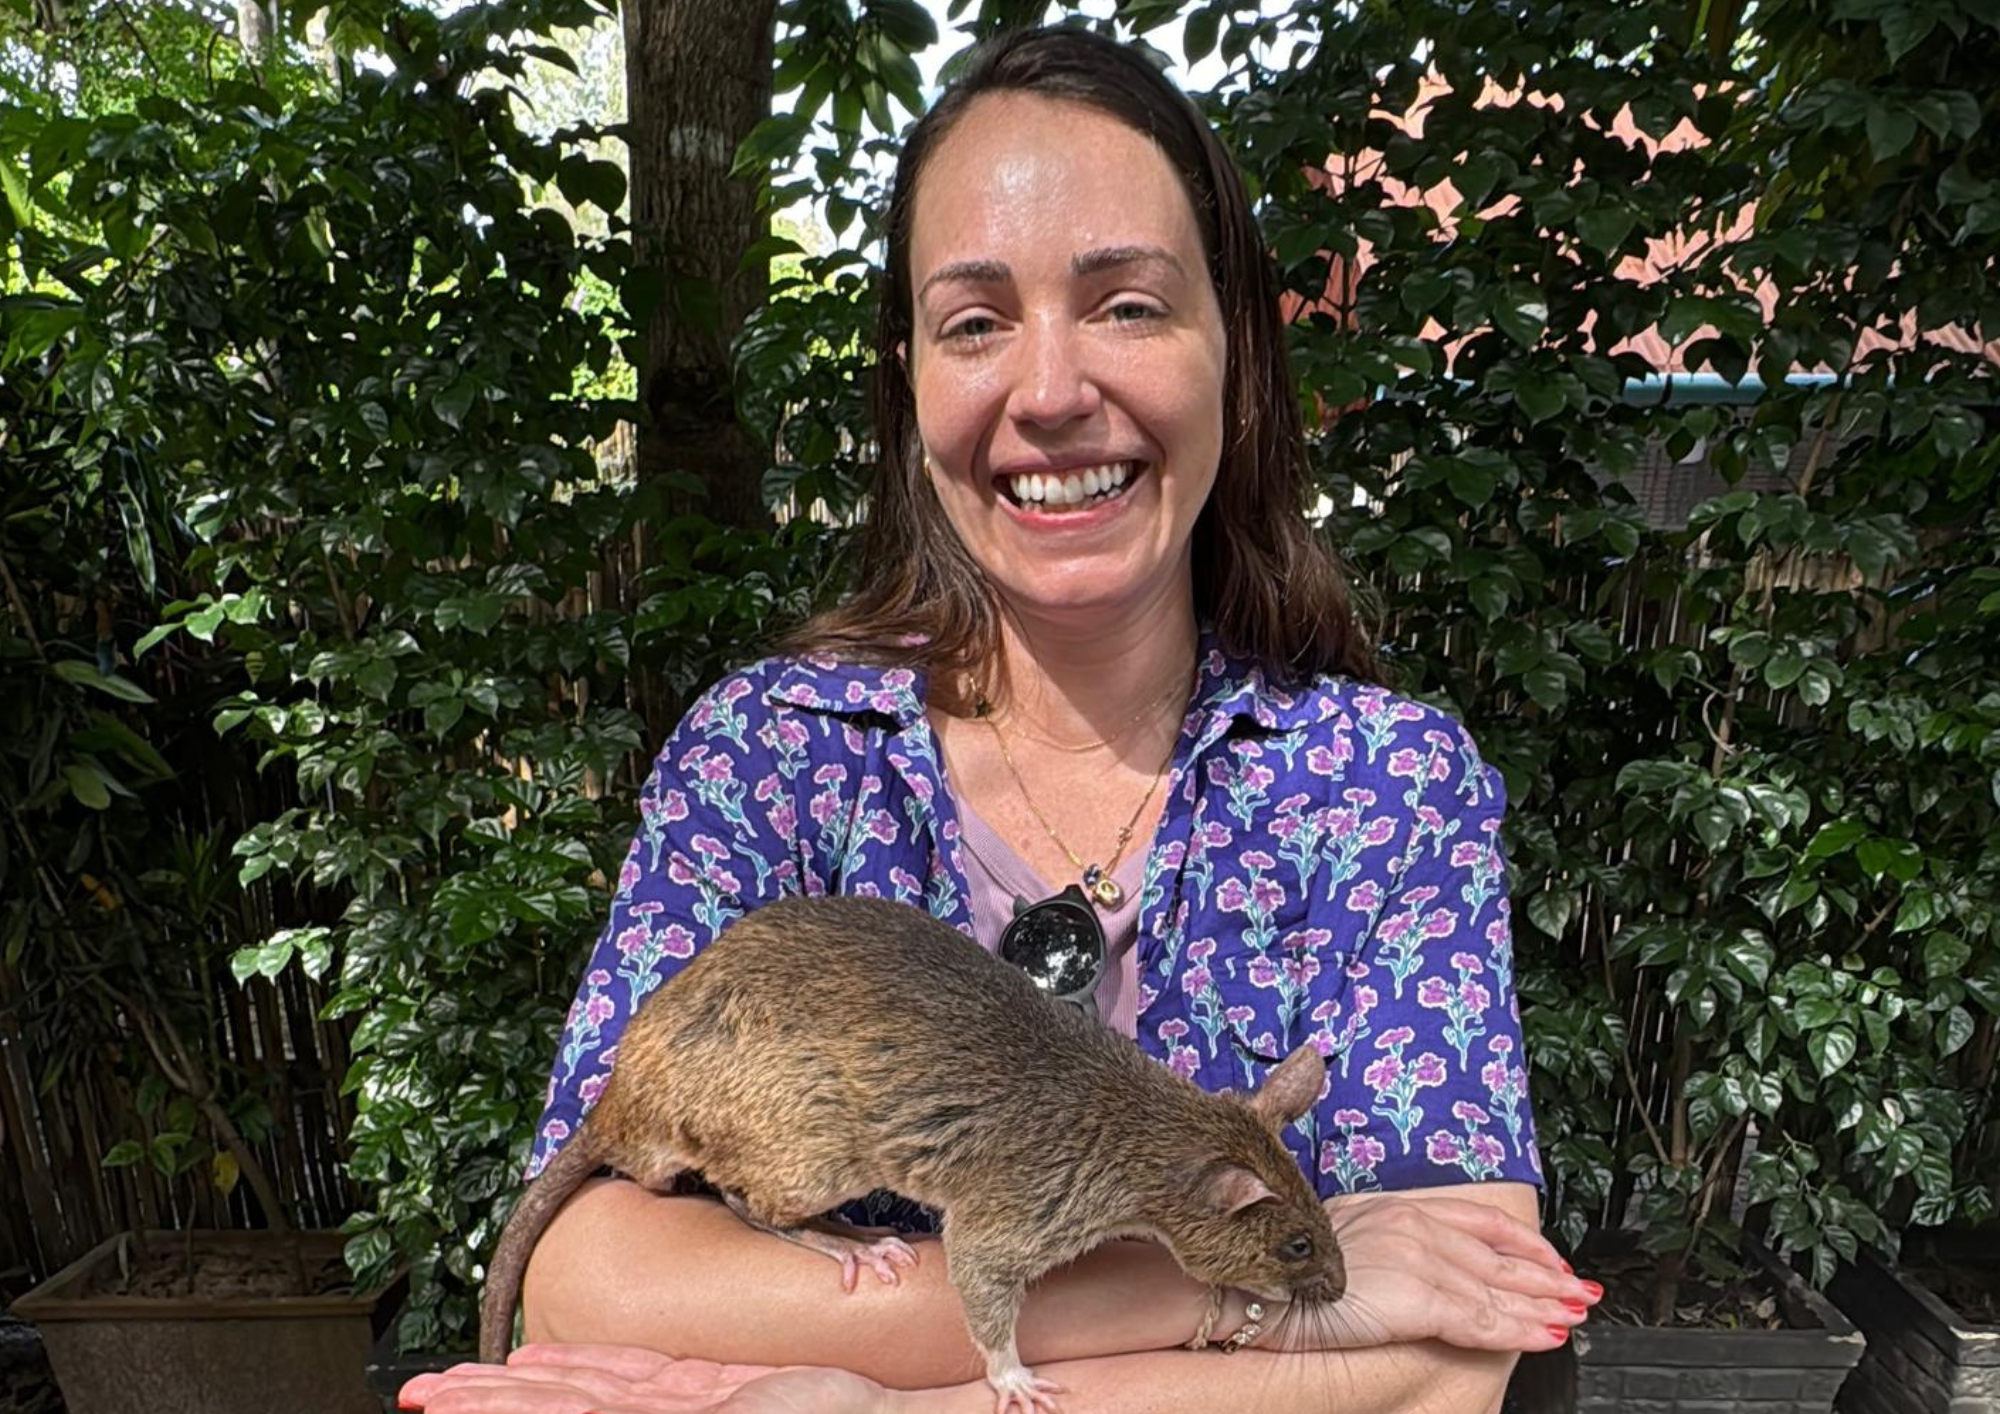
[14,1232,382,1414]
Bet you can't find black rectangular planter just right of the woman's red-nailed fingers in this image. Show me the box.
[1508,1242,1862,1414]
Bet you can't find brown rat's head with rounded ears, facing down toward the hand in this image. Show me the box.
[1162,1044,1348,1302]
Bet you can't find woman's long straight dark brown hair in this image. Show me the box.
[788,26,1376,684]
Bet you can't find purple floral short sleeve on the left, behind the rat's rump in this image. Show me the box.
[528,674,798,1178]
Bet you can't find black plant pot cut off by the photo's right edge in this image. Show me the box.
[1826,1238,2000,1414]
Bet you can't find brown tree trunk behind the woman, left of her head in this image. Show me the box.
[624,0,776,526]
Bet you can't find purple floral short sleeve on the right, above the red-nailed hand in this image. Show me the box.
[1322,708,1542,1188]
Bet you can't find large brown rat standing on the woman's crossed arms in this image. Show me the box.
[480,898,1346,1414]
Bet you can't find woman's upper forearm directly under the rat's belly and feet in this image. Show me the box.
[522,1180,1206,1410]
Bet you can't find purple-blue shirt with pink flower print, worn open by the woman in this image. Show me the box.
[528,644,1542,1216]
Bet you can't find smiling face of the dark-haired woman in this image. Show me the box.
[906,94,1226,620]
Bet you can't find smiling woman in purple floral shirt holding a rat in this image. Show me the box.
[406,30,1596,1414]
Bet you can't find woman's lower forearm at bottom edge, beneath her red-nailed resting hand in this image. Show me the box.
[894,1340,1516,1414]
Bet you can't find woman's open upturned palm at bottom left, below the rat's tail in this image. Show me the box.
[398,1344,900,1414]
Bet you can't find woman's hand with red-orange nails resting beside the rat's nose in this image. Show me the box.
[1258,1194,1604,1352]
